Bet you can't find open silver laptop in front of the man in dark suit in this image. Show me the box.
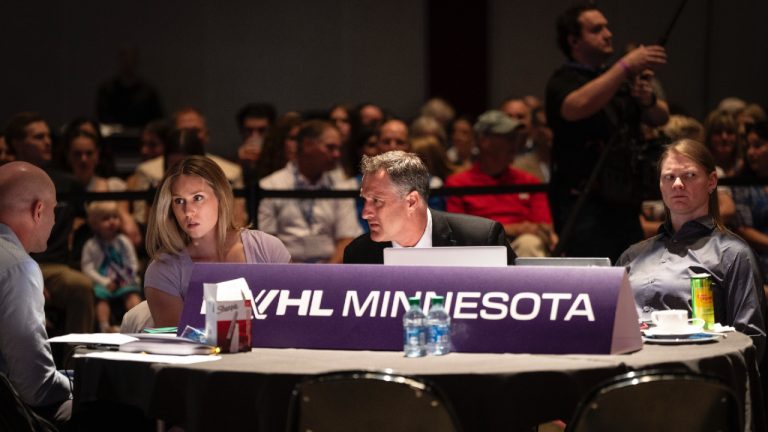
[384,246,507,267]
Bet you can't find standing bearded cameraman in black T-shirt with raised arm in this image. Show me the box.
[546,6,668,260]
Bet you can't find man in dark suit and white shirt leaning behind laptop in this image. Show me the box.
[344,151,515,265]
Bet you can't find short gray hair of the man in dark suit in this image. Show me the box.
[360,150,429,201]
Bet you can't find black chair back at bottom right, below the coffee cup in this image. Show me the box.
[566,370,742,432]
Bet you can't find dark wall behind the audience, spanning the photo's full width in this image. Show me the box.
[0,0,768,155]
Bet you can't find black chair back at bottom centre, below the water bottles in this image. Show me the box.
[288,371,461,432]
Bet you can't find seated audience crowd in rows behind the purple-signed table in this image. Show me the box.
[0,96,768,324]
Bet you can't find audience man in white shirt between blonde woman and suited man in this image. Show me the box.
[259,120,361,263]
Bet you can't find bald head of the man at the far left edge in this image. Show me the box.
[0,162,56,252]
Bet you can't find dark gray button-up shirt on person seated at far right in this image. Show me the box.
[616,216,765,355]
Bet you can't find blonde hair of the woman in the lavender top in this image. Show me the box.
[146,156,239,259]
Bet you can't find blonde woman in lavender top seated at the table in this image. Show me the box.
[144,156,291,327]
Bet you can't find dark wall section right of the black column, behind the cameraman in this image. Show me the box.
[489,0,768,119]
